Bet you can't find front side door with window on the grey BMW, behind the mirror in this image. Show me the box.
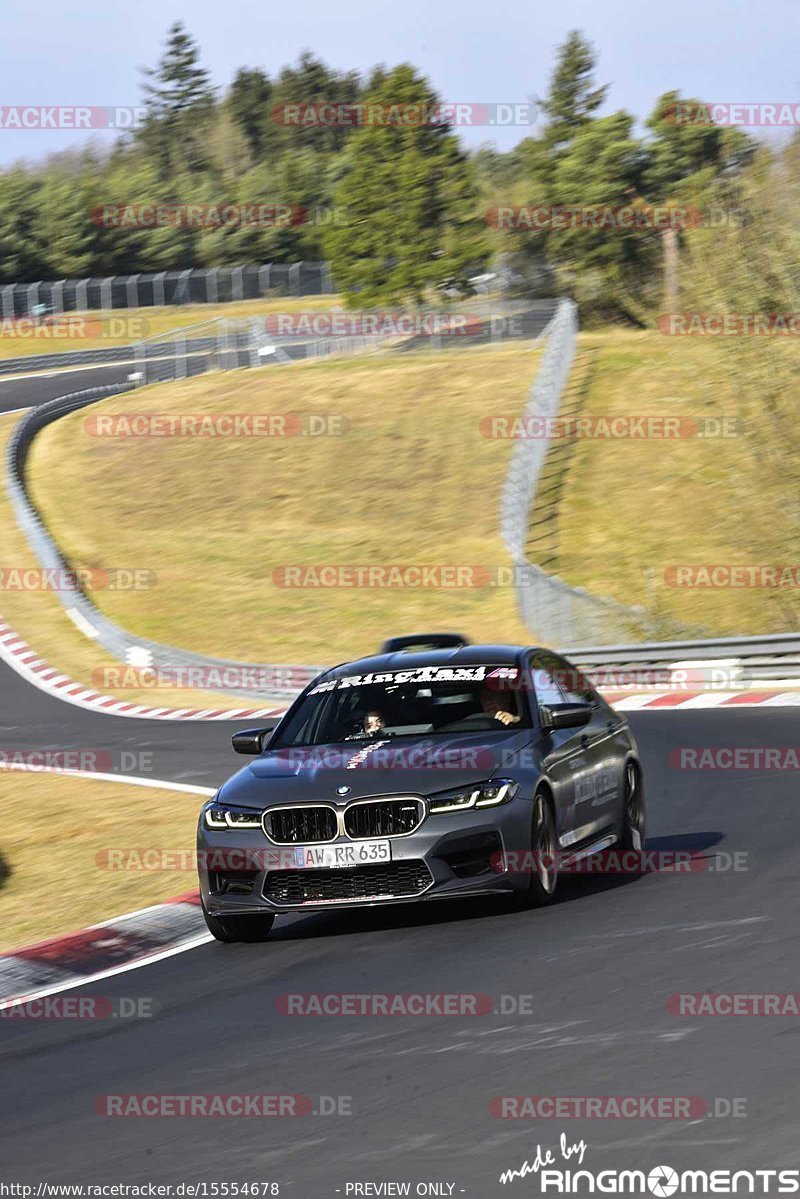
[528,650,589,849]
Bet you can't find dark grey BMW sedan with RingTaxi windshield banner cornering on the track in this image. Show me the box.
[198,633,645,941]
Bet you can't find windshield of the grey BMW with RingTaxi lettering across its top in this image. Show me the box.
[270,663,530,749]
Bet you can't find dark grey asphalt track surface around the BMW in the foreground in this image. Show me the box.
[0,618,800,1199]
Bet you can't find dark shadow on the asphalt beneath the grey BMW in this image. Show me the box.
[270,831,724,941]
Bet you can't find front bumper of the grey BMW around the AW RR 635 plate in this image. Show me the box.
[198,795,533,916]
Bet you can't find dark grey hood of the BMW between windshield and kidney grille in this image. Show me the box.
[219,729,531,807]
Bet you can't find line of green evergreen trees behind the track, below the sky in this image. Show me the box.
[0,23,770,323]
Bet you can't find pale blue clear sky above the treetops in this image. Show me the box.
[0,0,800,164]
